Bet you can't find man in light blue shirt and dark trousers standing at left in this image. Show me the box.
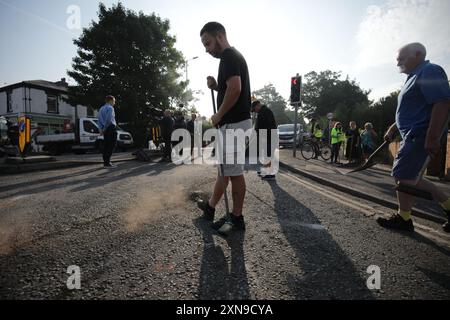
[98,96,117,168]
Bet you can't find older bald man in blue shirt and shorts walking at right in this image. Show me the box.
[377,43,450,232]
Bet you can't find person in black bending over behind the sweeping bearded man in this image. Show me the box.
[252,100,277,180]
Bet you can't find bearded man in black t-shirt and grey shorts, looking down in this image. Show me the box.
[198,22,252,235]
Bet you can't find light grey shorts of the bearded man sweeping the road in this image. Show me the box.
[219,119,252,177]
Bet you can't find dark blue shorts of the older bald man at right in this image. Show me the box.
[391,136,428,180]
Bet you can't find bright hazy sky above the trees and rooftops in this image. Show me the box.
[0,0,450,116]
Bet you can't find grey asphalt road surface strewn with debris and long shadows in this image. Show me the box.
[0,161,450,300]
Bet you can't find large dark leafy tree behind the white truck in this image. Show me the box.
[68,2,187,144]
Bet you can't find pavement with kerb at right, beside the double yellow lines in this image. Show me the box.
[280,149,450,223]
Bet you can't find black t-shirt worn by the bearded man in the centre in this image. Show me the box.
[217,48,252,126]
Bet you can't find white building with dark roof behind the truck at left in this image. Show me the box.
[0,78,95,134]
